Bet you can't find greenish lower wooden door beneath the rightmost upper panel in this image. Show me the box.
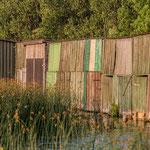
[132,76,147,113]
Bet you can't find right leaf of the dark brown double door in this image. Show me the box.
[34,59,44,86]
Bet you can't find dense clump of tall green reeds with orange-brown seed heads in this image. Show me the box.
[0,80,89,149]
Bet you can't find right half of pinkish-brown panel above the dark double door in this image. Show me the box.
[32,43,46,58]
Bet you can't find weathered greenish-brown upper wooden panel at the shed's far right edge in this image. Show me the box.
[133,35,150,75]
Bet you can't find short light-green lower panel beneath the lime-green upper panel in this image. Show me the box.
[46,72,57,86]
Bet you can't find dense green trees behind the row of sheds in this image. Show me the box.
[0,0,150,40]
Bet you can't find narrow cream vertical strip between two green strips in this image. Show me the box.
[89,40,96,71]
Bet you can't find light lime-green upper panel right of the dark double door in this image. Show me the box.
[48,43,61,71]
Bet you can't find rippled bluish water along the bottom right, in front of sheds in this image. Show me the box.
[37,122,150,150]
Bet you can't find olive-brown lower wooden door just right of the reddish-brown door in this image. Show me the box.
[101,75,113,112]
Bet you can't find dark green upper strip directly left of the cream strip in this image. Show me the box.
[84,40,91,71]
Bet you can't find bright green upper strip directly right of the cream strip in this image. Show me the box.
[94,39,102,71]
